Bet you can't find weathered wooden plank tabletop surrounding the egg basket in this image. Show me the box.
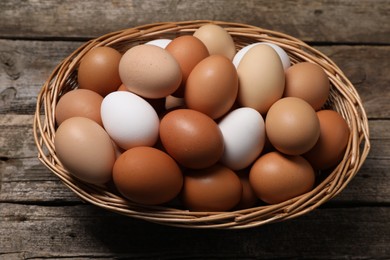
[0,0,390,259]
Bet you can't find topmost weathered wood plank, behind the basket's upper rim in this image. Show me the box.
[0,0,390,44]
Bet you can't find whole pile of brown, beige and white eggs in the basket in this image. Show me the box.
[54,24,350,211]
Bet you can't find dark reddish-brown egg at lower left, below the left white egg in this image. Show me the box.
[113,146,183,205]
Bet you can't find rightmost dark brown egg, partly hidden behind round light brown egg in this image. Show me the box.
[303,110,350,170]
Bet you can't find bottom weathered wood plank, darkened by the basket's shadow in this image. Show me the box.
[0,204,390,259]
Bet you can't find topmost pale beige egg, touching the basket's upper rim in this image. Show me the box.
[193,24,236,60]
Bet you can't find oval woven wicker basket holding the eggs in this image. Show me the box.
[33,20,370,228]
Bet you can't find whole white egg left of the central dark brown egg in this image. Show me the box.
[101,91,160,150]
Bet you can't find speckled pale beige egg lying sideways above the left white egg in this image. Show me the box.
[119,44,182,98]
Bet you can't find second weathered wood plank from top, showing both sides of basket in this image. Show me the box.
[0,40,390,118]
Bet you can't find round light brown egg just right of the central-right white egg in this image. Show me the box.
[265,97,320,155]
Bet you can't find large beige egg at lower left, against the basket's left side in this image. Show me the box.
[54,117,116,185]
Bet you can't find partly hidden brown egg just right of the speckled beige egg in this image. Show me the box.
[165,35,209,97]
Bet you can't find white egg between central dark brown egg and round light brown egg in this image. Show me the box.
[218,107,265,170]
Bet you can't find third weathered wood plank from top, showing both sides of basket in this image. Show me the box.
[0,115,390,204]
